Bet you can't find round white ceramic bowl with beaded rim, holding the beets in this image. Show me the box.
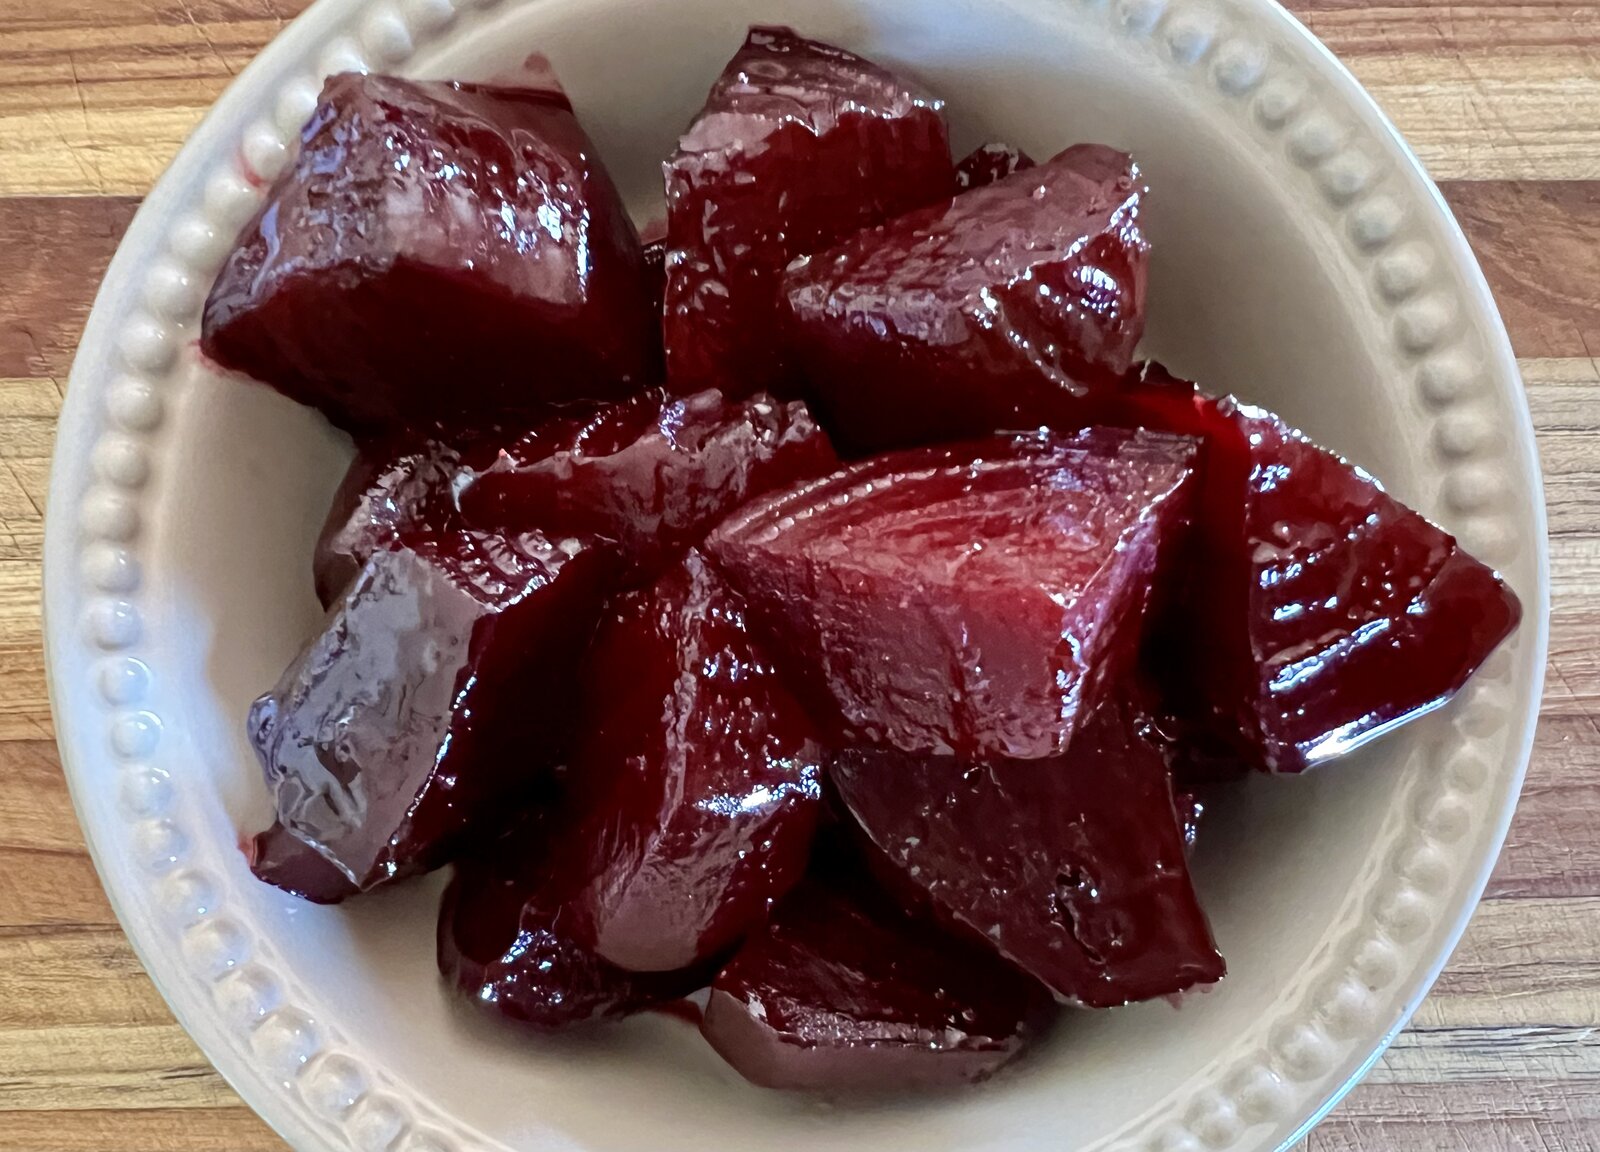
[45,0,1547,1152]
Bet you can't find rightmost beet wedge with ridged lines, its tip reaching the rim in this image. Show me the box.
[1126,368,1522,771]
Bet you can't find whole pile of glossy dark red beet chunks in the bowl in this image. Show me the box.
[203,29,1520,1090]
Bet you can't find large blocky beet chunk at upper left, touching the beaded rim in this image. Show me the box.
[202,74,659,430]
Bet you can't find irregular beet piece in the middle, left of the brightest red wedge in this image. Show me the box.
[461,390,838,574]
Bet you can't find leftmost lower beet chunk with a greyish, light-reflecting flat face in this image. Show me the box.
[250,531,611,891]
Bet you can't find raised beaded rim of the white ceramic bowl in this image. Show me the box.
[45,0,1549,1152]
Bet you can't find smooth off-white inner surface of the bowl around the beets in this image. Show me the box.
[134,0,1536,1152]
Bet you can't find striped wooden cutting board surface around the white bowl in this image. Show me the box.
[0,0,1600,1152]
